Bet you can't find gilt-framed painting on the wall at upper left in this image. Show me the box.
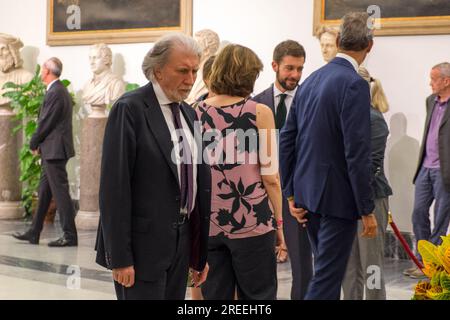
[47,0,193,46]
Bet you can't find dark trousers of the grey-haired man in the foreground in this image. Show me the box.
[114,223,190,300]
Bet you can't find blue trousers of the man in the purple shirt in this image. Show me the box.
[412,167,450,259]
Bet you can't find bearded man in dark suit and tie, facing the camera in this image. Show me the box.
[253,40,312,300]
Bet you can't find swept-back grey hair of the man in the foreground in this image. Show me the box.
[142,32,202,80]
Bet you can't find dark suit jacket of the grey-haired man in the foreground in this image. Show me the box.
[96,83,211,281]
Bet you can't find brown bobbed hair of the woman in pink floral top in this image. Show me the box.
[209,44,263,97]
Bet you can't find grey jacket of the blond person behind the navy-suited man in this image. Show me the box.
[370,108,392,199]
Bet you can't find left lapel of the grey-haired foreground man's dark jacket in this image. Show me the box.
[144,83,178,182]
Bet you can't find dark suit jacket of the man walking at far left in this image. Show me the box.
[30,80,75,160]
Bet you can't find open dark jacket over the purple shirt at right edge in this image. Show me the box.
[413,94,450,192]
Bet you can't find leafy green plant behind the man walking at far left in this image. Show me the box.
[3,65,73,217]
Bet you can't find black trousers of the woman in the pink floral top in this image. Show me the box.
[202,231,277,300]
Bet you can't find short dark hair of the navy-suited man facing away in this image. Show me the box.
[338,12,373,51]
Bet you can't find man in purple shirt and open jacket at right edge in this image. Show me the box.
[404,62,450,278]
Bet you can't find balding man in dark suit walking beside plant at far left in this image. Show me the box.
[13,58,78,247]
